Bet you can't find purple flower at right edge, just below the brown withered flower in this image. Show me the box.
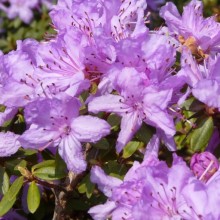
[179,50,220,108]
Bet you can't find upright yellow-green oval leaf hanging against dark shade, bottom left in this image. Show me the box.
[27,181,40,213]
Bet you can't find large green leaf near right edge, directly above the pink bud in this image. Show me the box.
[190,117,214,151]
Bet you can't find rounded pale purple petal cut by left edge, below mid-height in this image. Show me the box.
[0,131,21,157]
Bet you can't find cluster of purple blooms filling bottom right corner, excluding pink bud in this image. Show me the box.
[89,136,220,220]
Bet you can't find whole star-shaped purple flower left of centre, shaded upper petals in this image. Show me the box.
[19,98,110,173]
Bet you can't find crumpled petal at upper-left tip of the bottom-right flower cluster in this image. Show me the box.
[91,166,122,197]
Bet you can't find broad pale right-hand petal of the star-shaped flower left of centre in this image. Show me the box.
[71,115,111,142]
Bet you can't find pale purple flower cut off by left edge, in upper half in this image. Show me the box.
[0,39,40,108]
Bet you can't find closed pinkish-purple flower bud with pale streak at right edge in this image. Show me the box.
[190,152,219,182]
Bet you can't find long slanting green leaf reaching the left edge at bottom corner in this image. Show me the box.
[0,176,24,216]
